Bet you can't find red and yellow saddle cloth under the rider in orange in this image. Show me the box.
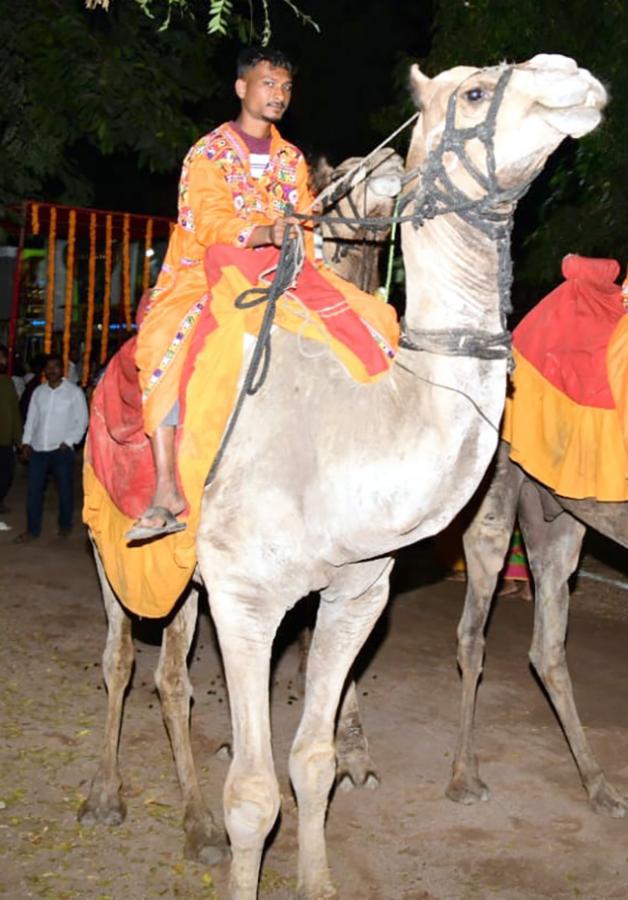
[83,244,398,618]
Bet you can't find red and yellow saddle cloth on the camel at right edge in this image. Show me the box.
[502,255,628,501]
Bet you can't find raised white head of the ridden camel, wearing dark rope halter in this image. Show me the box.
[407,54,607,204]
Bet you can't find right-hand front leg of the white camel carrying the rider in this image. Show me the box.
[290,559,393,900]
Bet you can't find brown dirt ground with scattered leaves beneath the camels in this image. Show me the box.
[0,460,628,900]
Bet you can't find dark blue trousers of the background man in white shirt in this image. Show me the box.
[26,447,74,537]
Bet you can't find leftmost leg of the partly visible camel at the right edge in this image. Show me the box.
[446,443,524,804]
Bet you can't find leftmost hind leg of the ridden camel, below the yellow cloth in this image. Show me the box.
[77,546,134,825]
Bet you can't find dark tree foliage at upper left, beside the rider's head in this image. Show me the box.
[0,0,314,204]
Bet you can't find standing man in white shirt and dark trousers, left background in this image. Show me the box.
[15,353,88,544]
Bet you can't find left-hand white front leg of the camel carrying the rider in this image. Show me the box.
[210,589,285,900]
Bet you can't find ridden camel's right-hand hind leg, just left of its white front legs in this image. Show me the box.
[155,588,228,865]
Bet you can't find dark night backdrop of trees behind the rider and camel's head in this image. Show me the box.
[0,0,628,306]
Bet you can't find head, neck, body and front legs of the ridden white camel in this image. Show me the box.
[81,55,606,900]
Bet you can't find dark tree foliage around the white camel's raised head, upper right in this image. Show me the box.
[426,0,628,300]
